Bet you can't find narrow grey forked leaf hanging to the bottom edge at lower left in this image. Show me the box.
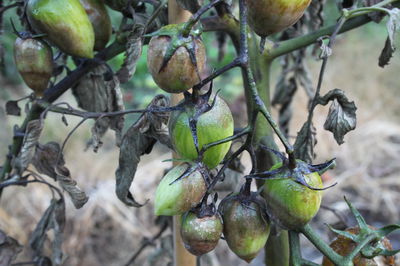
[29,199,65,265]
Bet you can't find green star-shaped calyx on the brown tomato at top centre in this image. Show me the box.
[144,23,202,75]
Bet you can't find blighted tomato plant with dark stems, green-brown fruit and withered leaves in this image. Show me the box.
[0,0,400,266]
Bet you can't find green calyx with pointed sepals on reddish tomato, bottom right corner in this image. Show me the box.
[327,197,400,259]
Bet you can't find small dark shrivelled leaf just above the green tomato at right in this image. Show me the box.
[294,122,317,163]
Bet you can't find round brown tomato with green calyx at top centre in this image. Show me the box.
[147,25,206,93]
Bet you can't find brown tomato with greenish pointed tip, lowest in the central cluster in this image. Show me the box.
[220,197,270,263]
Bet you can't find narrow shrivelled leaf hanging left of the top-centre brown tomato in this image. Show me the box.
[117,24,144,83]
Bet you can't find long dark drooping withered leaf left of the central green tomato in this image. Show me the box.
[115,95,171,207]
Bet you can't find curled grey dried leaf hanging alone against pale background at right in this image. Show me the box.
[320,89,357,145]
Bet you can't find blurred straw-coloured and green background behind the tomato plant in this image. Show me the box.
[0,1,400,266]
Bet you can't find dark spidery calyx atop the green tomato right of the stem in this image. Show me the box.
[245,150,337,190]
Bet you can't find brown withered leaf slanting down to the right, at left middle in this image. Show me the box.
[32,142,88,209]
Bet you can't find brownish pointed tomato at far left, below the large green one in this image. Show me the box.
[14,38,53,97]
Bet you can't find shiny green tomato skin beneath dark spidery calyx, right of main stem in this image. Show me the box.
[263,163,322,230]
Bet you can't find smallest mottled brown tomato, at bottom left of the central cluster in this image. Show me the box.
[181,212,223,256]
